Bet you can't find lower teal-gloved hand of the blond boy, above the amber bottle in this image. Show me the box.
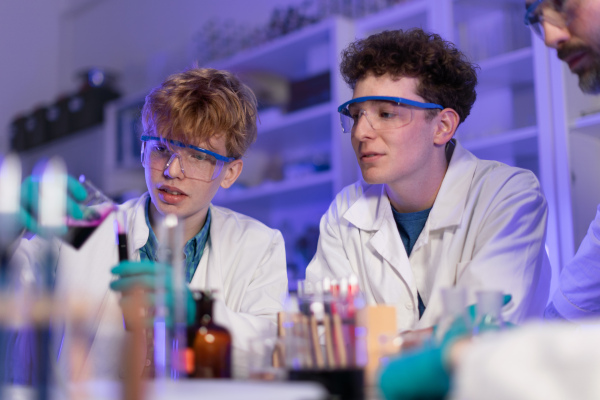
[110,260,196,326]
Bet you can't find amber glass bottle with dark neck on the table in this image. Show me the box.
[188,291,231,378]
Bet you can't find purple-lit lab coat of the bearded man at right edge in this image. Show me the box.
[552,206,600,320]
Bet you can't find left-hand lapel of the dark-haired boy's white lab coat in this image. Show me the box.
[344,185,415,288]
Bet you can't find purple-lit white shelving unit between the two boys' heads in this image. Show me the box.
[207,18,358,275]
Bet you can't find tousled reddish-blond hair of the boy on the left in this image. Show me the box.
[142,67,257,158]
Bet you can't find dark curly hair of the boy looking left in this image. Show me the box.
[340,28,479,123]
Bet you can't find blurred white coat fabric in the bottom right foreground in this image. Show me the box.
[450,320,600,400]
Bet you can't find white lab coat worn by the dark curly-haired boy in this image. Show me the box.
[306,143,550,331]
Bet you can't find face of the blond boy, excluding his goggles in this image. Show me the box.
[144,135,243,223]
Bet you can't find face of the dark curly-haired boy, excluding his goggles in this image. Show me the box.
[352,74,436,186]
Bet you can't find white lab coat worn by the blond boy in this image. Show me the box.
[15,194,287,378]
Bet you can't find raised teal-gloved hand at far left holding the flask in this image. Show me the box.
[20,175,87,233]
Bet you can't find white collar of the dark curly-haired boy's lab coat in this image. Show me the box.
[343,139,477,231]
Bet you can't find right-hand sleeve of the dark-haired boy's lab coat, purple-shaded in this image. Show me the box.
[457,170,550,323]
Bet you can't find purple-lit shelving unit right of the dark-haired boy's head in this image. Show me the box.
[452,0,540,173]
